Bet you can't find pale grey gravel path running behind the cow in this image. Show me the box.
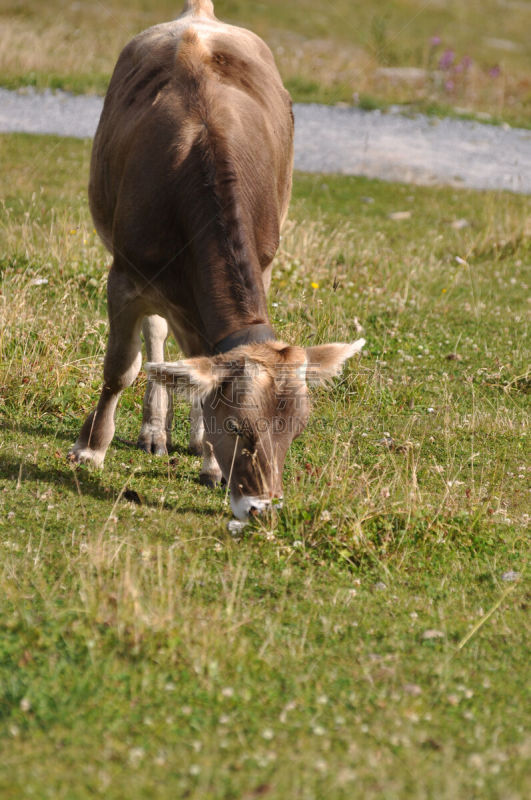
[0,89,531,194]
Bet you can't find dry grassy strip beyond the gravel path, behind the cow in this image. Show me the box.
[0,0,531,126]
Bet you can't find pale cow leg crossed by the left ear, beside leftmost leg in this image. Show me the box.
[137,314,173,456]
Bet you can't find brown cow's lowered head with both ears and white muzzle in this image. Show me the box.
[146,339,365,520]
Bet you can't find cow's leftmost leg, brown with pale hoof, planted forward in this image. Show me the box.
[69,266,144,467]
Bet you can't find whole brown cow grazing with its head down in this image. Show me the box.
[69,0,362,519]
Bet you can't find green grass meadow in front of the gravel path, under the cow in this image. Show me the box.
[0,136,531,800]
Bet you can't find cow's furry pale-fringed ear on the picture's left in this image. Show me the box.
[146,356,223,398]
